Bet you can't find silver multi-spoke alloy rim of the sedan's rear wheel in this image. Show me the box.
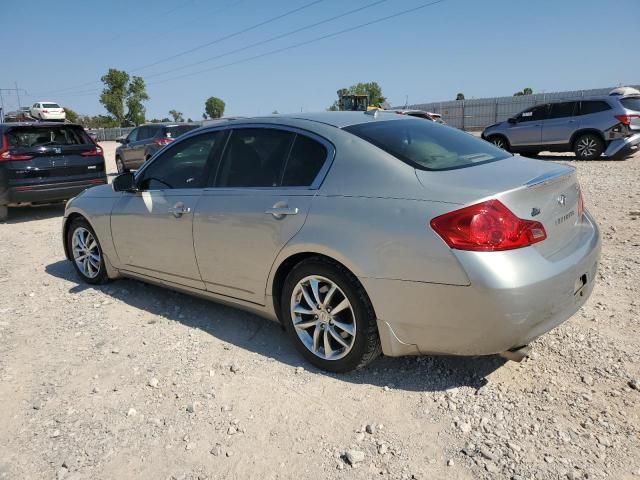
[290,275,356,360]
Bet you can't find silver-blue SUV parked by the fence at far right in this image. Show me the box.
[482,95,640,160]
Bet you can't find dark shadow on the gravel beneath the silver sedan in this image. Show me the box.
[45,260,506,392]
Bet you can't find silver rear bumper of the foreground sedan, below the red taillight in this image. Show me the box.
[361,211,601,356]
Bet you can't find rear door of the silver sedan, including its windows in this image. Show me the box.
[193,126,333,305]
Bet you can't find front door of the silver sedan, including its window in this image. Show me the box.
[111,132,219,290]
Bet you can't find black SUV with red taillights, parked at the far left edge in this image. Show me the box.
[0,122,107,221]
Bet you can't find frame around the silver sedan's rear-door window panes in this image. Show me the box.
[205,123,336,191]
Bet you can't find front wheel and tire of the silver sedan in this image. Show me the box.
[66,218,109,285]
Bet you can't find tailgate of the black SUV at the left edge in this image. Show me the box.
[1,125,105,188]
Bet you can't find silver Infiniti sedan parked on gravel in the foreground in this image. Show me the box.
[63,112,600,372]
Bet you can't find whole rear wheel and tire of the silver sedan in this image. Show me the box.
[280,257,382,373]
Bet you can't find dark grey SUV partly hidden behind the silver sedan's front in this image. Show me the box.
[116,123,198,173]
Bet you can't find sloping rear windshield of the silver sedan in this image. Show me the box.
[345,119,511,170]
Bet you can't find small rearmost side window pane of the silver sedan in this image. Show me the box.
[282,135,327,187]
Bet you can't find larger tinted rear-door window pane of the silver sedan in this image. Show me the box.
[216,128,295,188]
